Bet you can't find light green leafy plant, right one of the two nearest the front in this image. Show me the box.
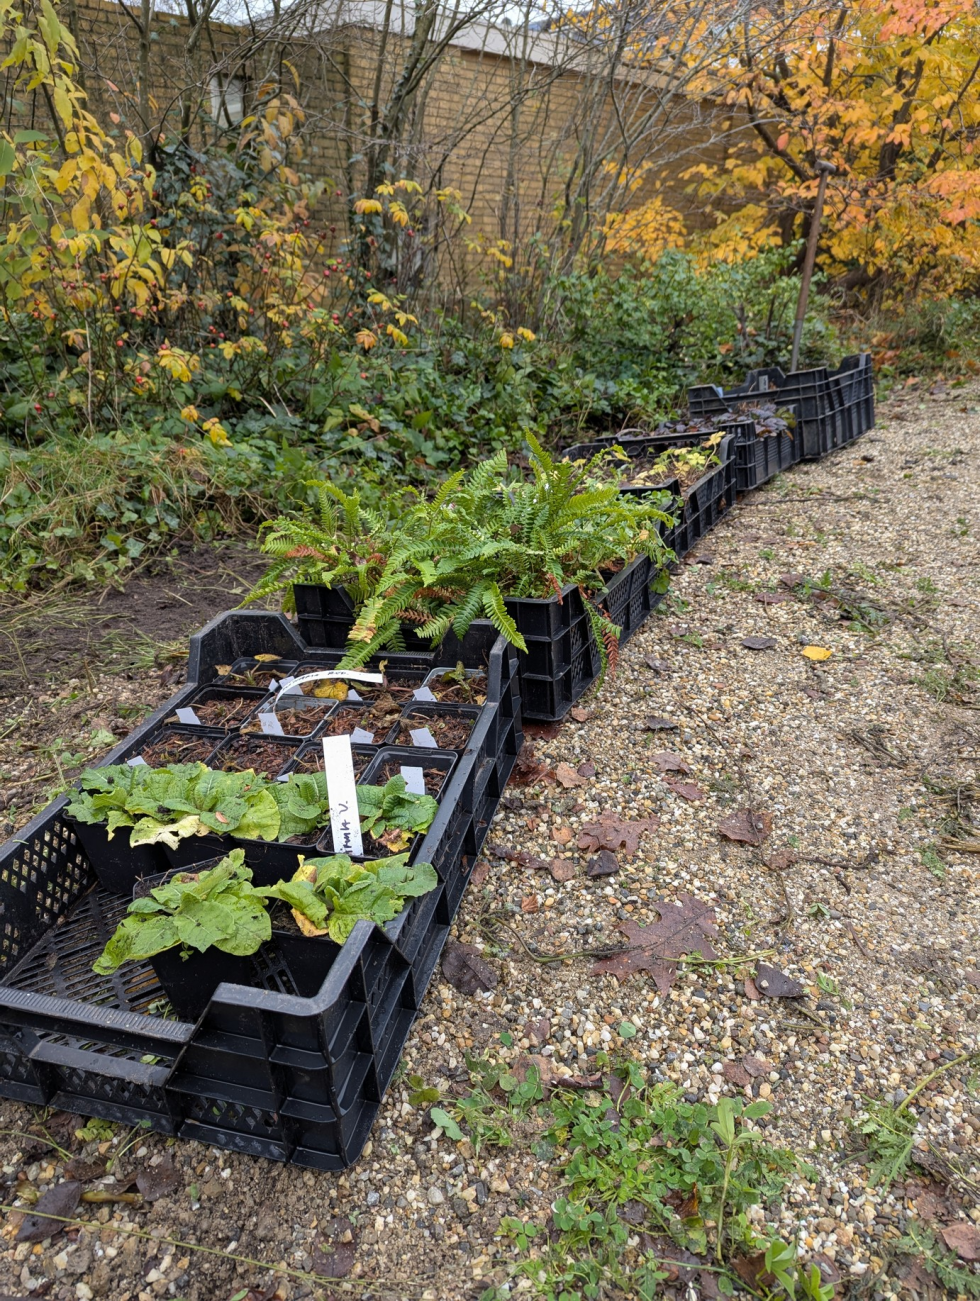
[265,853,439,945]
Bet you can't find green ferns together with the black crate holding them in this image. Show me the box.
[247,436,672,717]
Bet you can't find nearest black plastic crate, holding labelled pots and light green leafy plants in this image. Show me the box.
[0,611,523,1170]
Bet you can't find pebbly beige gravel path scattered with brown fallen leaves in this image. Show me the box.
[0,388,980,1301]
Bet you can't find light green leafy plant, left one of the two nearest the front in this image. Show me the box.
[92,850,272,976]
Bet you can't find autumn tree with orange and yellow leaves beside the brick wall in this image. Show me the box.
[691,0,980,307]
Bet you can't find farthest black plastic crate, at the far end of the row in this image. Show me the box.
[687,353,875,461]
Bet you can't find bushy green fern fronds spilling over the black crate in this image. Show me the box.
[246,435,672,669]
